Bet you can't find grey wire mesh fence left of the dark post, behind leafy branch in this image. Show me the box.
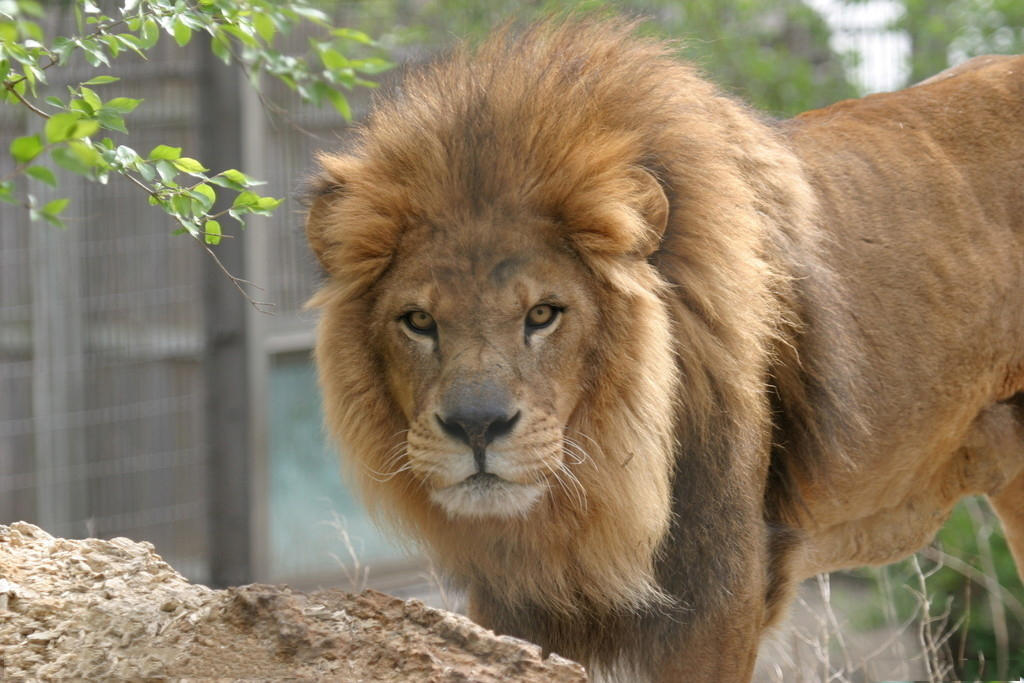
[0,31,207,579]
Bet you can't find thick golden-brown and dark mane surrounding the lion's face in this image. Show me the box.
[307,20,856,671]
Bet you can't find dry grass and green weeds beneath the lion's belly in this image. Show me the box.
[757,500,1024,683]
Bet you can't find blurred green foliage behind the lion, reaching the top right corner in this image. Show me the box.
[338,0,1024,109]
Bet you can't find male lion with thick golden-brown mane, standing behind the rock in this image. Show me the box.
[306,17,1024,681]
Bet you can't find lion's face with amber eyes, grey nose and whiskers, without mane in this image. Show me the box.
[371,211,599,517]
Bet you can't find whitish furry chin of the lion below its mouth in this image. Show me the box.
[430,473,544,518]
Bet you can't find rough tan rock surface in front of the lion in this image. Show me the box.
[0,522,586,682]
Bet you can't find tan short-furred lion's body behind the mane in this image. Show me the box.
[786,63,1024,574]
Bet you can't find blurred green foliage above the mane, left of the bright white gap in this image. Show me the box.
[327,0,857,116]
